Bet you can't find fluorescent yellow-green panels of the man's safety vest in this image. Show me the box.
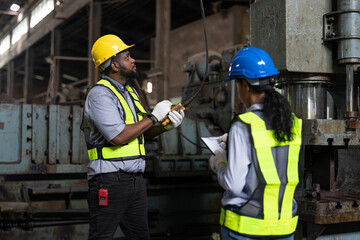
[88,79,146,161]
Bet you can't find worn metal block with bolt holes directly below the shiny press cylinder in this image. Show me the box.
[303,119,360,146]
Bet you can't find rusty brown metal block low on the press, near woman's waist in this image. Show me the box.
[300,191,360,224]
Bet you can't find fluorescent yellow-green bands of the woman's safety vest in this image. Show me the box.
[220,112,302,236]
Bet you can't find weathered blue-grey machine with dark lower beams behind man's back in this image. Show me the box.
[0,104,88,239]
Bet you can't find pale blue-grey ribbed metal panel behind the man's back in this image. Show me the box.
[0,104,88,174]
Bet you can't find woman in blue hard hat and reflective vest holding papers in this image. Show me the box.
[209,47,303,240]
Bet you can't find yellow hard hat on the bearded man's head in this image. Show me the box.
[91,34,135,67]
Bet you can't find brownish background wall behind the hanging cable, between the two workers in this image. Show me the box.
[148,6,250,104]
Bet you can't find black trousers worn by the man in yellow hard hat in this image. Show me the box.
[88,172,150,240]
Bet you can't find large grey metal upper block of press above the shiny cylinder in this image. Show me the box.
[250,0,336,73]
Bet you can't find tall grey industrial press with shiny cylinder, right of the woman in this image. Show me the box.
[250,0,360,239]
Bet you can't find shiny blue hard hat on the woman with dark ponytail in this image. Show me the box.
[224,47,280,84]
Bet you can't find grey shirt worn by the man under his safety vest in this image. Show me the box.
[84,76,145,179]
